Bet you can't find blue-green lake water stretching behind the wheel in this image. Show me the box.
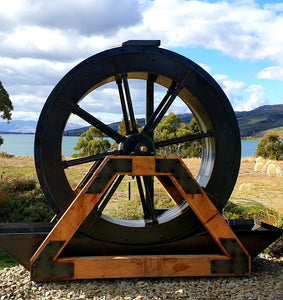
[0,134,259,157]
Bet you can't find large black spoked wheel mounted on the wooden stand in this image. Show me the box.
[35,41,241,245]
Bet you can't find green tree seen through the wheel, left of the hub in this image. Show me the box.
[72,127,111,157]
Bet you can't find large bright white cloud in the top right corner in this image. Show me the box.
[131,0,283,61]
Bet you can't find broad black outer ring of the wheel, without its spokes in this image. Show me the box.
[35,46,241,244]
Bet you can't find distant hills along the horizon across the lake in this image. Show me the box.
[0,104,283,137]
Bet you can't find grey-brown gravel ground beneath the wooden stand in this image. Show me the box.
[0,255,283,300]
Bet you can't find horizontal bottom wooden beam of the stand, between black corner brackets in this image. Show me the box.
[58,255,231,279]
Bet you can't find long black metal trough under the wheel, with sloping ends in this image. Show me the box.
[0,220,283,269]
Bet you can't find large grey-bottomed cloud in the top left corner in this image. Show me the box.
[0,0,142,35]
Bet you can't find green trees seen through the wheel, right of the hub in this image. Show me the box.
[154,113,201,157]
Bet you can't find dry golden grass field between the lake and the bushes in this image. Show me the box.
[0,157,283,213]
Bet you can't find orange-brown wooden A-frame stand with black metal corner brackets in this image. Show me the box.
[30,156,251,281]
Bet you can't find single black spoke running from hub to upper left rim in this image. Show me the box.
[72,105,126,143]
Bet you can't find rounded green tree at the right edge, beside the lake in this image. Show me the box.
[256,133,283,160]
